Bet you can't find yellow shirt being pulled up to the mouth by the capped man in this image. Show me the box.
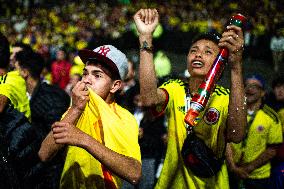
[60,90,141,189]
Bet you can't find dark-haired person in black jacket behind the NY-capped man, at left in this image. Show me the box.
[15,51,70,189]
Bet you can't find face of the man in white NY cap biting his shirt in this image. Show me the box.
[82,64,117,100]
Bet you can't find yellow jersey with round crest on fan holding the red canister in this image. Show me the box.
[155,80,229,189]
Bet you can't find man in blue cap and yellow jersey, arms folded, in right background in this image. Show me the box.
[227,75,283,189]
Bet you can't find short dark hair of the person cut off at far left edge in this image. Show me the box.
[0,32,10,69]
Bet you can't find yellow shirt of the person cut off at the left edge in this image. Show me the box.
[0,71,31,119]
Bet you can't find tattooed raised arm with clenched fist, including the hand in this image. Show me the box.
[133,9,166,107]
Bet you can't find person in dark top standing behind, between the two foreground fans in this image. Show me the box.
[122,93,167,189]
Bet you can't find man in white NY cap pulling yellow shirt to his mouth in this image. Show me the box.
[39,45,141,189]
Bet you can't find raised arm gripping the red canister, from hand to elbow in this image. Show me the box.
[219,25,247,143]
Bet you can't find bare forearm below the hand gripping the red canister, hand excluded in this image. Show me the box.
[226,64,247,143]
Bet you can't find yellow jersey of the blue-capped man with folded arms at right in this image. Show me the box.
[231,105,283,179]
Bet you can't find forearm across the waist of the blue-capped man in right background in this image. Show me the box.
[244,147,276,172]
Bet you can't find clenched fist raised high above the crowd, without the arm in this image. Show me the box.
[133,9,159,35]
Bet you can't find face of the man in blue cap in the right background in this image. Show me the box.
[245,79,265,104]
